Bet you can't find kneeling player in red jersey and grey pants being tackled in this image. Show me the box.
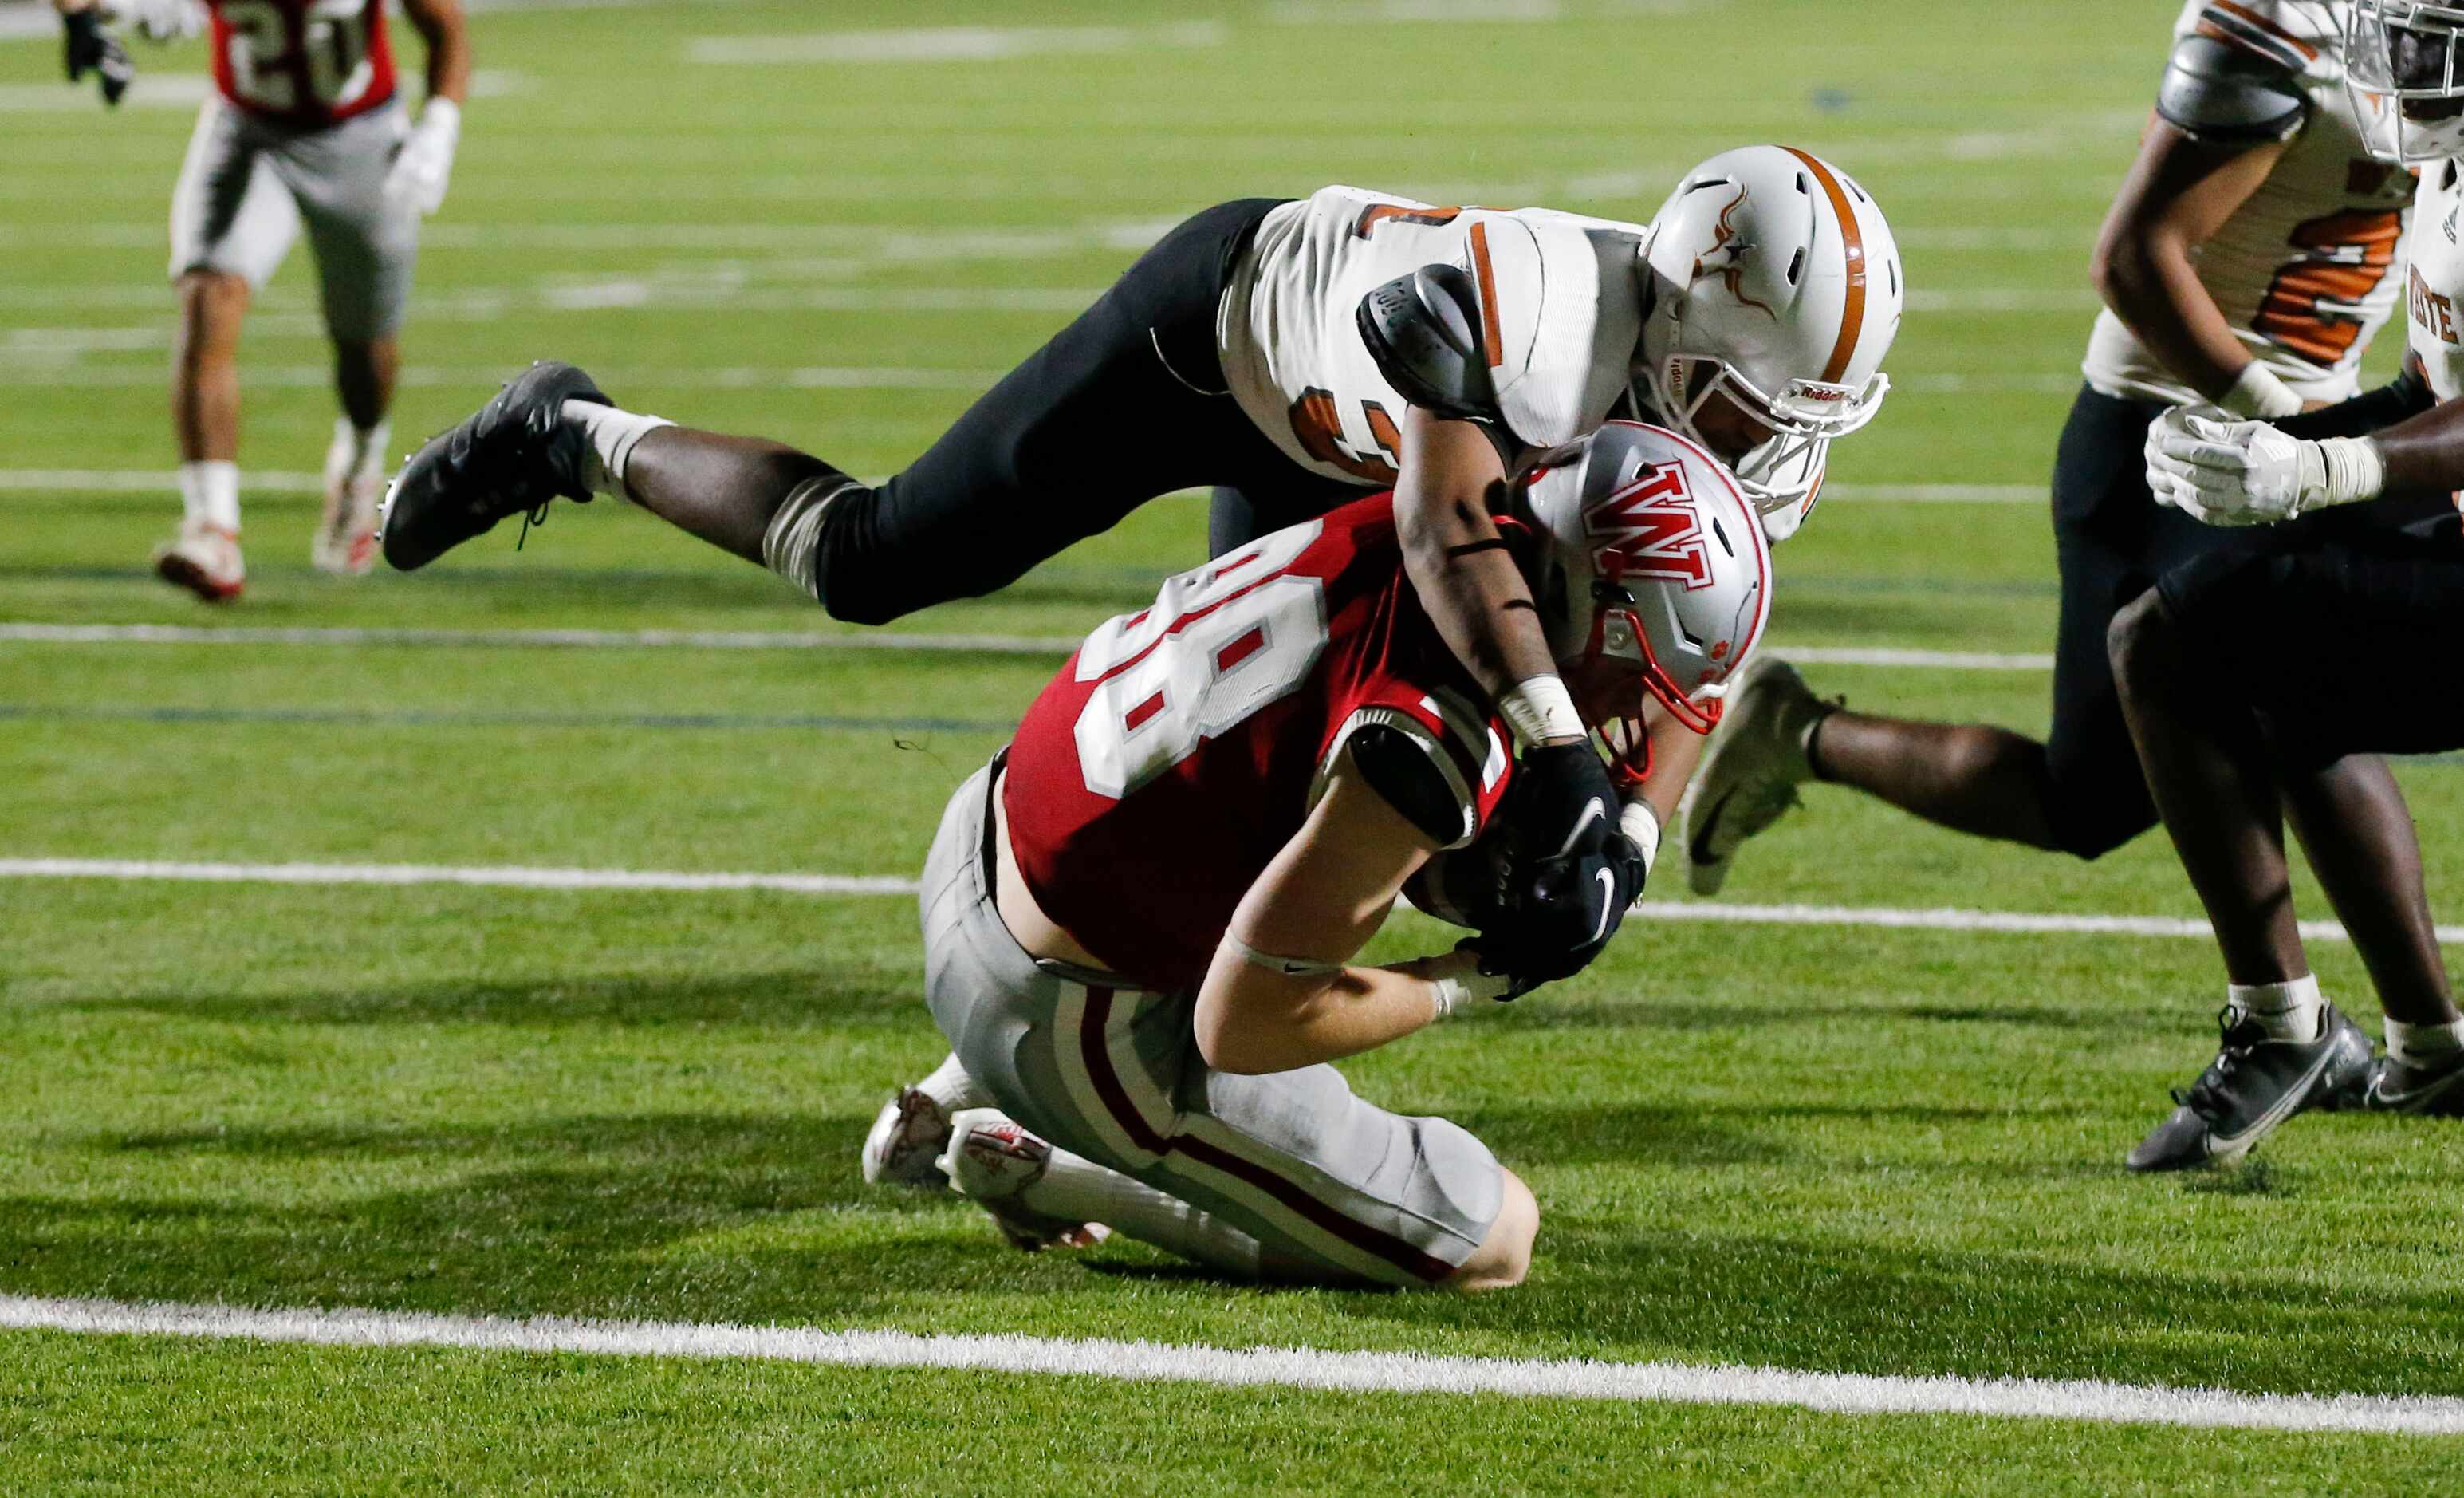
[865,421,1769,1288]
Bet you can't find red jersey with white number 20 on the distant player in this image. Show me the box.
[204,0,394,131]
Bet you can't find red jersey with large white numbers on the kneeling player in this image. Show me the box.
[1003,495,1513,993]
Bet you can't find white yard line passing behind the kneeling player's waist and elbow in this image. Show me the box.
[0,857,2464,944]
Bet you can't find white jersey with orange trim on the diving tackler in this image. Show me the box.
[1214,187,1646,488]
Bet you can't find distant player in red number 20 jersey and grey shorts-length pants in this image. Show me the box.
[54,0,470,601]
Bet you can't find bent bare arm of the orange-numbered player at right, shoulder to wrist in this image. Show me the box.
[2092,37,2309,416]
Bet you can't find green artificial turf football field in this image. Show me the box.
[0,0,2464,1493]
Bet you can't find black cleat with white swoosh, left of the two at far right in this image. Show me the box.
[2129,1005,2371,1170]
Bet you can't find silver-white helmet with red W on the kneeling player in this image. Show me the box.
[1521,421,1772,754]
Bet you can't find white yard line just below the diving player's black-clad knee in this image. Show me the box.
[0,621,2053,670]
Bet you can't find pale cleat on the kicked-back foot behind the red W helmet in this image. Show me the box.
[1678,658,1833,894]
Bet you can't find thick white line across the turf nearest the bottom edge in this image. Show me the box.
[0,1296,2464,1437]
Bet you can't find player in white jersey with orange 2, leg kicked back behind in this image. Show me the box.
[1686,0,2415,1024]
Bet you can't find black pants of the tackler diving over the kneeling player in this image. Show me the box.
[816,197,1368,623]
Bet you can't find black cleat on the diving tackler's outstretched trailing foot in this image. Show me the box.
[377,360,616,572]
